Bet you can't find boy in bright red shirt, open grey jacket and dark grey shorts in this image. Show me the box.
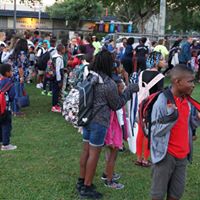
[151,64,200,200]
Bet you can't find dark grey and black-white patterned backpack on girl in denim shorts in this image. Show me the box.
[62,71,103,127]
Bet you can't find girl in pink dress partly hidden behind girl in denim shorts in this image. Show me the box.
[101,76,127,189]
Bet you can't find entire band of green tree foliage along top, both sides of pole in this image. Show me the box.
[46,0,200,31]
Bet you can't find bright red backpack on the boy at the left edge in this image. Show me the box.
[0,82,13,121]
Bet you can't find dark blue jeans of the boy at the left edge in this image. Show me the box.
[0,111,12,146]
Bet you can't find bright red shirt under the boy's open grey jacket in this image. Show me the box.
[168,96,190,159]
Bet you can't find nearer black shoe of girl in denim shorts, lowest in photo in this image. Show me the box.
[80,186,103,199]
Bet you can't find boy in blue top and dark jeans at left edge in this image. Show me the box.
[0,64,17,151]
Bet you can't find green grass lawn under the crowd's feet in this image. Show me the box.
[0,85,200,200]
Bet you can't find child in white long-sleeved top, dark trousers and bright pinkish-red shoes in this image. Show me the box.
[51,44,65,112]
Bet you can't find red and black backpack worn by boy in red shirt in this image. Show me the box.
[139,88,178,147]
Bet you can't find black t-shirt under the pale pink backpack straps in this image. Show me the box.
[142,70,164,94]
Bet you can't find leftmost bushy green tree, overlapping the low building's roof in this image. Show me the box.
[47,0,103,29]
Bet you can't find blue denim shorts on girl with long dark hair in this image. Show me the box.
[83,122,107,147]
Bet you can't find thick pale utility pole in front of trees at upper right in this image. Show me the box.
[158,0,166,36]
